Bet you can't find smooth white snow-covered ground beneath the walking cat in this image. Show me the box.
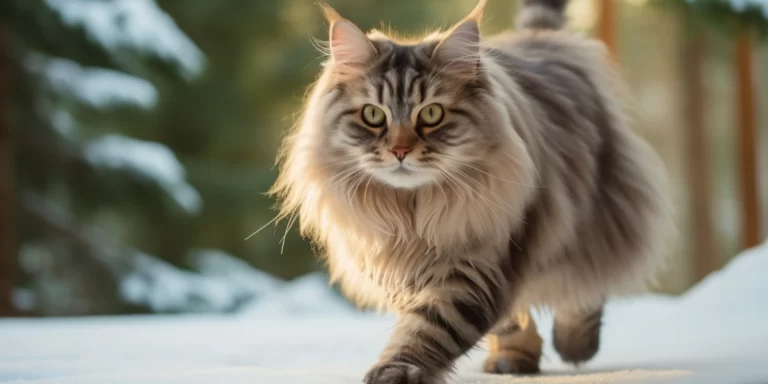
[0,244,768,384]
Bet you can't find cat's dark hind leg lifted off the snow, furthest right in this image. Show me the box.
[552,305,603,365]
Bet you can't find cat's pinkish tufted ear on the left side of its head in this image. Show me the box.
[318,1,376,69]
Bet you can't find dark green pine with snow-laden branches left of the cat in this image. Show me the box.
[0,0,206,315]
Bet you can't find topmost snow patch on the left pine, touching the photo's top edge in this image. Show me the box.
[46,0,205,78]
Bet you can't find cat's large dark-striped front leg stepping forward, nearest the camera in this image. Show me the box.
[364,263,511,384]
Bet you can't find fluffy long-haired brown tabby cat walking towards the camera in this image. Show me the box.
[270,0,673,384]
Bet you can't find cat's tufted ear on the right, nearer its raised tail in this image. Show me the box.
[433,0,486,77]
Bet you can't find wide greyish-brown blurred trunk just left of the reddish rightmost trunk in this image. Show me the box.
[681,18,720,281]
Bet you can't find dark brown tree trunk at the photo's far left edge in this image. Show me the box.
[0,24,17,316]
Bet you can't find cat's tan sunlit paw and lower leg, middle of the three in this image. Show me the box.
[483,310,542,374]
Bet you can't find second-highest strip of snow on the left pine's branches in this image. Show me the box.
[27,55,158,109]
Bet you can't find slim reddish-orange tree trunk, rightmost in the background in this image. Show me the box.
[734,32,762,248]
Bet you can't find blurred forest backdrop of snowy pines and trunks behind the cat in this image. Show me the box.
[0,0,768,316]
